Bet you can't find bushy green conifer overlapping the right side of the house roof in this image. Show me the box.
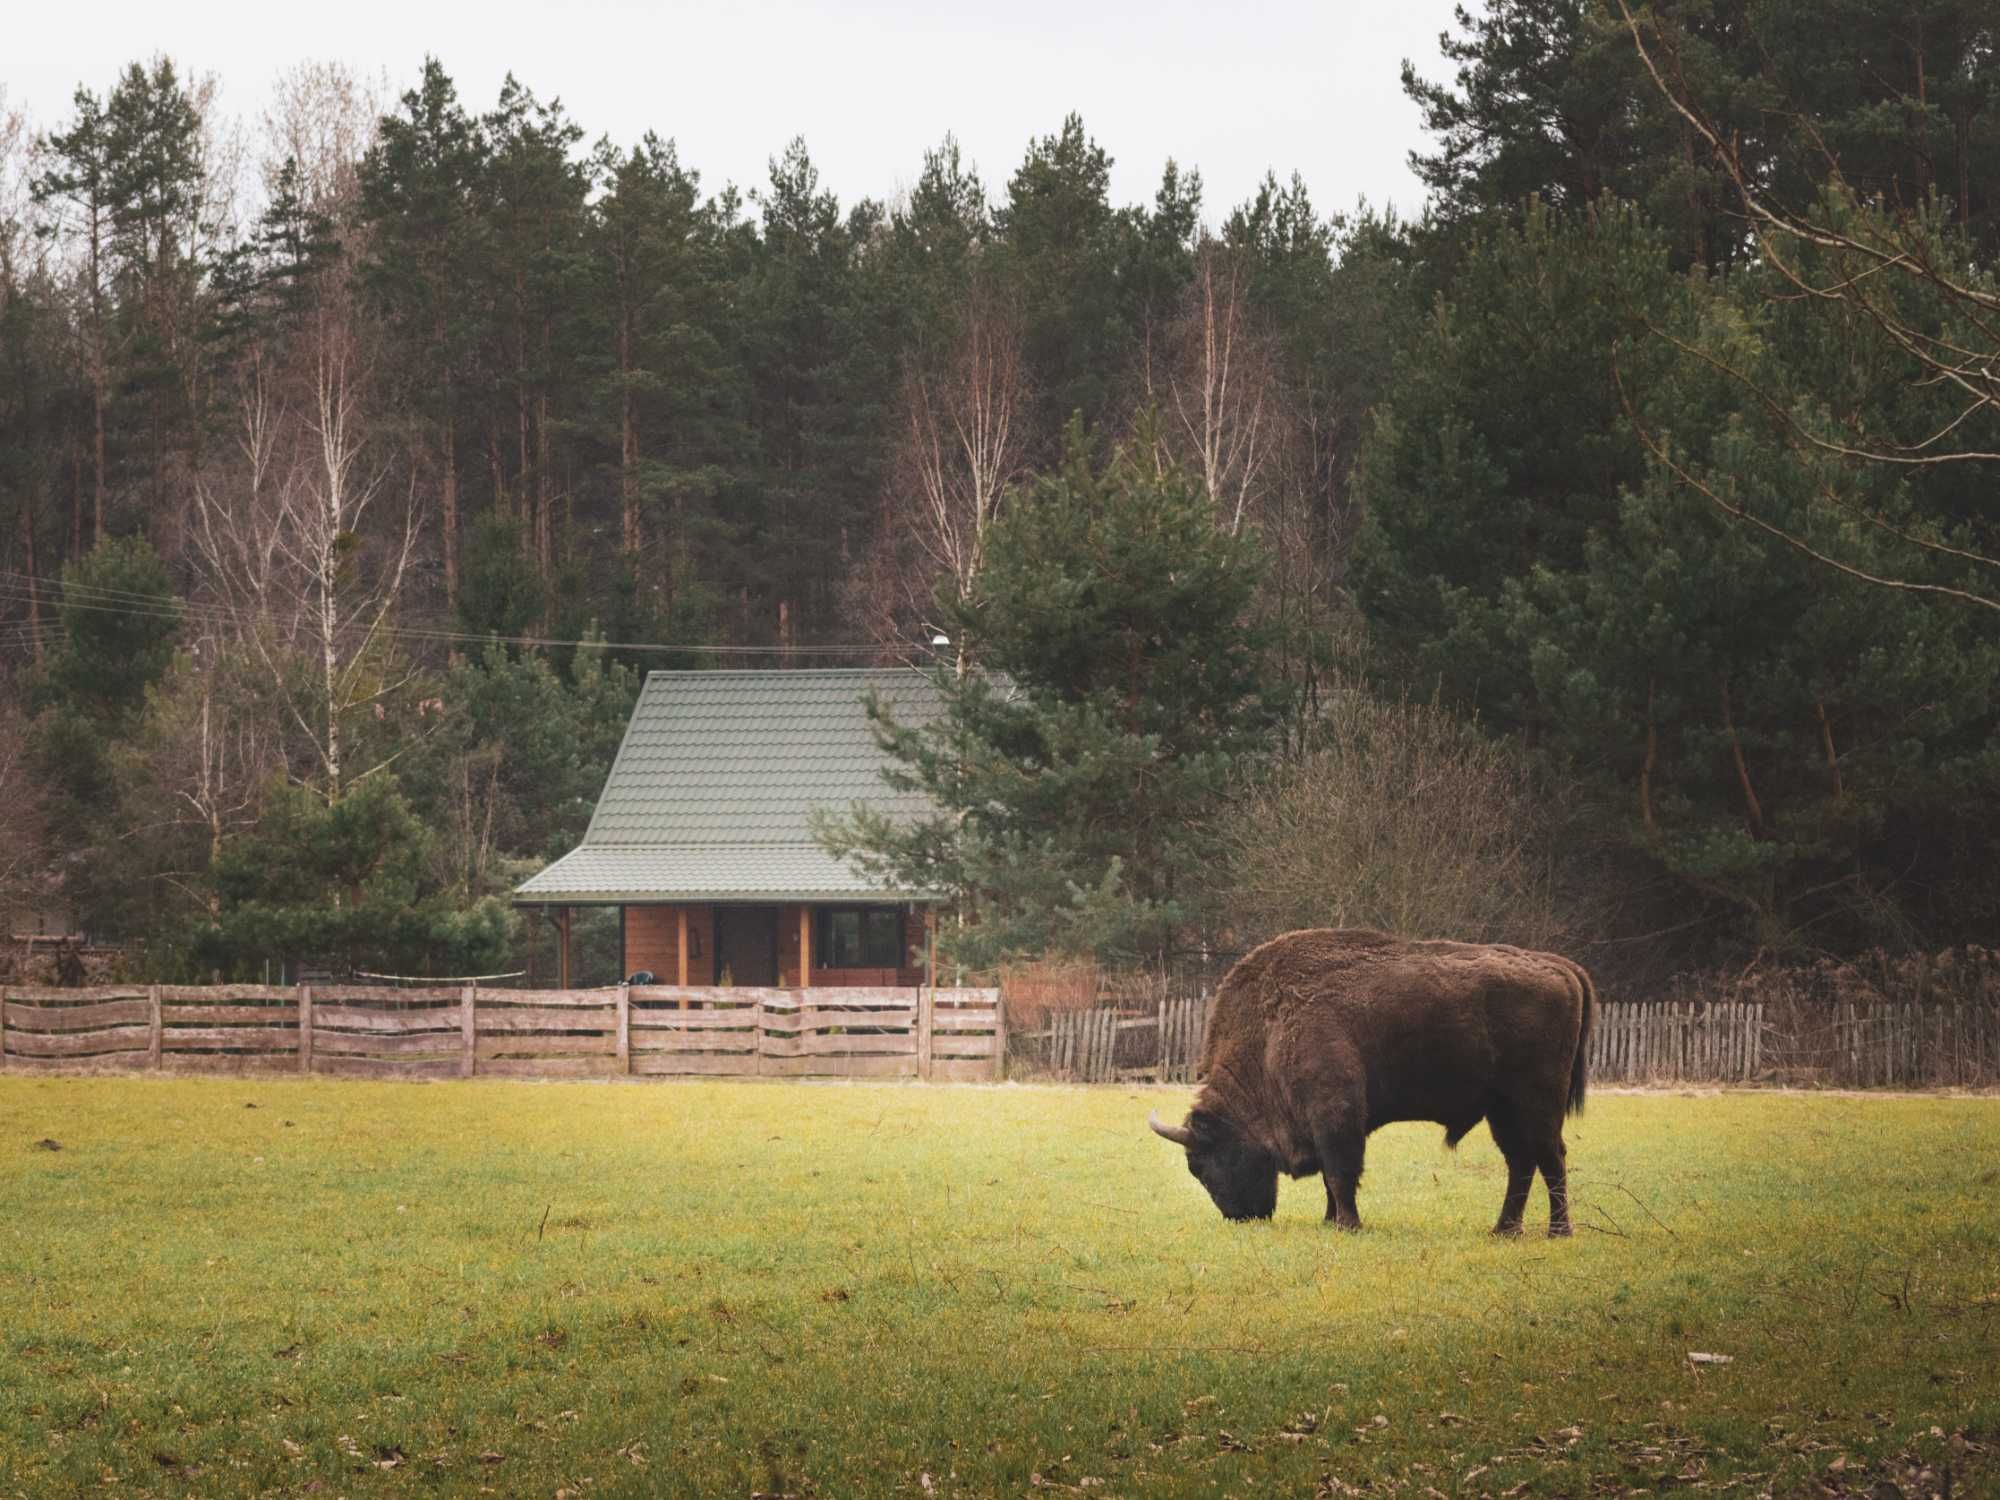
[820,424,1280,968]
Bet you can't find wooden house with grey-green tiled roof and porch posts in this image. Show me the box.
[514,668,938,988]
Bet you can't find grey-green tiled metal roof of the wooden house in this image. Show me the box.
[514,668,938,904]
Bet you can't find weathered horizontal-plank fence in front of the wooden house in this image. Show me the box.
[0,984,1006,1082]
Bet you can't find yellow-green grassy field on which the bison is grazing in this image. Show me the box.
[0,1076,2000,1496]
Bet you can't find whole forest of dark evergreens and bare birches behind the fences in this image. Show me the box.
[0,0,2000,1000]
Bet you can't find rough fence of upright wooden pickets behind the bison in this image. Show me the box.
[1014,998,2000,1088]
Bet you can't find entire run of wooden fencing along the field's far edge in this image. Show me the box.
[11,984,2000,1088]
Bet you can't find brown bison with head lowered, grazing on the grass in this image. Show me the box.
[1154,928,1596,1234]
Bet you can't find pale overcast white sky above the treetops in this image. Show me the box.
[0,0,1452,222]
